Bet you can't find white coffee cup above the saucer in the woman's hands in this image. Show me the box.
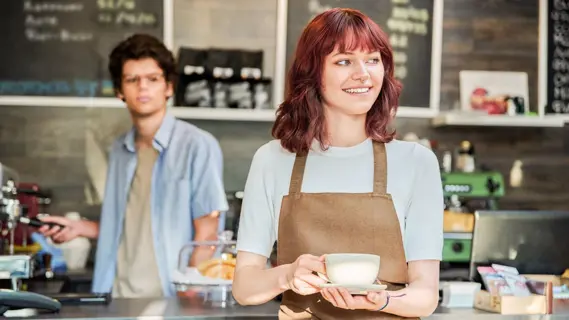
[325,253,380,285]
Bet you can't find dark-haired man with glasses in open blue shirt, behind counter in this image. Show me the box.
[40,35,228,297]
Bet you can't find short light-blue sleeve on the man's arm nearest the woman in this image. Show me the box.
[190,134,228,219]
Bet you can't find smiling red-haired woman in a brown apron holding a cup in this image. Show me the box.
[233,8,443,319]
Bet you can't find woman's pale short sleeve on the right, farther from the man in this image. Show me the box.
[405,145,444,261]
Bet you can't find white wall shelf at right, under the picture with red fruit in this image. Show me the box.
[431,113,568,128]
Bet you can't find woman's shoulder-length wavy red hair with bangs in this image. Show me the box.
[272,8,401,153]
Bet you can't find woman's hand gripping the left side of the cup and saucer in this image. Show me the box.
[287,254,326,295]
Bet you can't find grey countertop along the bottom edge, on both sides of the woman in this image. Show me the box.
[11,298,569,320]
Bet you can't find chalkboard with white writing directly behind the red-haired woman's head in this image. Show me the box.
[286,0,434,108]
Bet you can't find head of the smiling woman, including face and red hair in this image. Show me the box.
[273,10,401,152]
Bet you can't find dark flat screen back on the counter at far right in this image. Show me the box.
[469,210,569,279]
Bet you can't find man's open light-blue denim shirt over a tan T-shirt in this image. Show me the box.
[92,115,228,297]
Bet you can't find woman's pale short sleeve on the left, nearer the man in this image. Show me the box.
[237,145,276,258]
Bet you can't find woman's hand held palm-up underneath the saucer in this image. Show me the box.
[320,288,387,311]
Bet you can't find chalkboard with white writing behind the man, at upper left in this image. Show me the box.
[0,0,164,97]
